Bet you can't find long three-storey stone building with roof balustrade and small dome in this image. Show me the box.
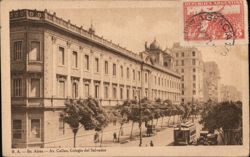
[10,9,182,147]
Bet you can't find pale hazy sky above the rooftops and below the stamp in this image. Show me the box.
[49,4,248,90]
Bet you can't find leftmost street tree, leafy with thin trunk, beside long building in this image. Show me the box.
[61,97,109,147]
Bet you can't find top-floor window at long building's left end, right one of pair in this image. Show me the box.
[29,41,40,61]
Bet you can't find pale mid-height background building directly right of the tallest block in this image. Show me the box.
[204,62,220,102]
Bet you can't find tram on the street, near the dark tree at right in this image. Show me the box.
[174,122,196,145]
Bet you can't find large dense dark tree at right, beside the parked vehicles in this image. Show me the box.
[200,102,242,144]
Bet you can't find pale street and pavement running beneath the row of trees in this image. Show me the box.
[44,116,201,147]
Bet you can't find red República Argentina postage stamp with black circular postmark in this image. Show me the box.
[183,0,246,45]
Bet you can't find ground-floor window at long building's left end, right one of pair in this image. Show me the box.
[30,119,41,139]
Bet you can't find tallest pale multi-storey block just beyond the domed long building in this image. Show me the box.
[171,43,204,103]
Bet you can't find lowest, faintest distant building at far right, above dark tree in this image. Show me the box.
[220,84,242,102]
